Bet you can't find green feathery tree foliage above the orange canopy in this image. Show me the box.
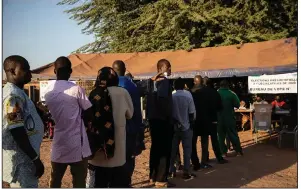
[59,0,297,52]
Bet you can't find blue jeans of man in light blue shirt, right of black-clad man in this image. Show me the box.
[169,129,193,173]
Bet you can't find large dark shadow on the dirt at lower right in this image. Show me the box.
[164,135,298,188]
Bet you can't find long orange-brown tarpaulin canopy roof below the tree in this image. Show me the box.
[33,38,297,78]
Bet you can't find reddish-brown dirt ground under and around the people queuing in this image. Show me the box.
[39,131,298,188]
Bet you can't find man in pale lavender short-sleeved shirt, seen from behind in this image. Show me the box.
[45,57,92,188]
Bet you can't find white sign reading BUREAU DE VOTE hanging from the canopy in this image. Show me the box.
[248,72,297,94]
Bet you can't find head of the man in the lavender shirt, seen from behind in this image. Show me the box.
[54,56,72,80]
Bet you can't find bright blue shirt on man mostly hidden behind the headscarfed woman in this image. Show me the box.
[119,76,144,134]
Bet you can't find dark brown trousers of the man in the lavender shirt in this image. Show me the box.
[49,160,88,188]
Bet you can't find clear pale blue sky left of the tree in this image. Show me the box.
[2,0,94,69]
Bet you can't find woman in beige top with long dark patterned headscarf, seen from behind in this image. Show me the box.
[87,67,134,188]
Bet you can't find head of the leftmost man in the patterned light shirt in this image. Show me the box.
[3,55,31,88]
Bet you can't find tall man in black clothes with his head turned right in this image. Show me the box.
[146,59,173,187]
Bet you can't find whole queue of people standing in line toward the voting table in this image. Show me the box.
[2,55,243,188]
